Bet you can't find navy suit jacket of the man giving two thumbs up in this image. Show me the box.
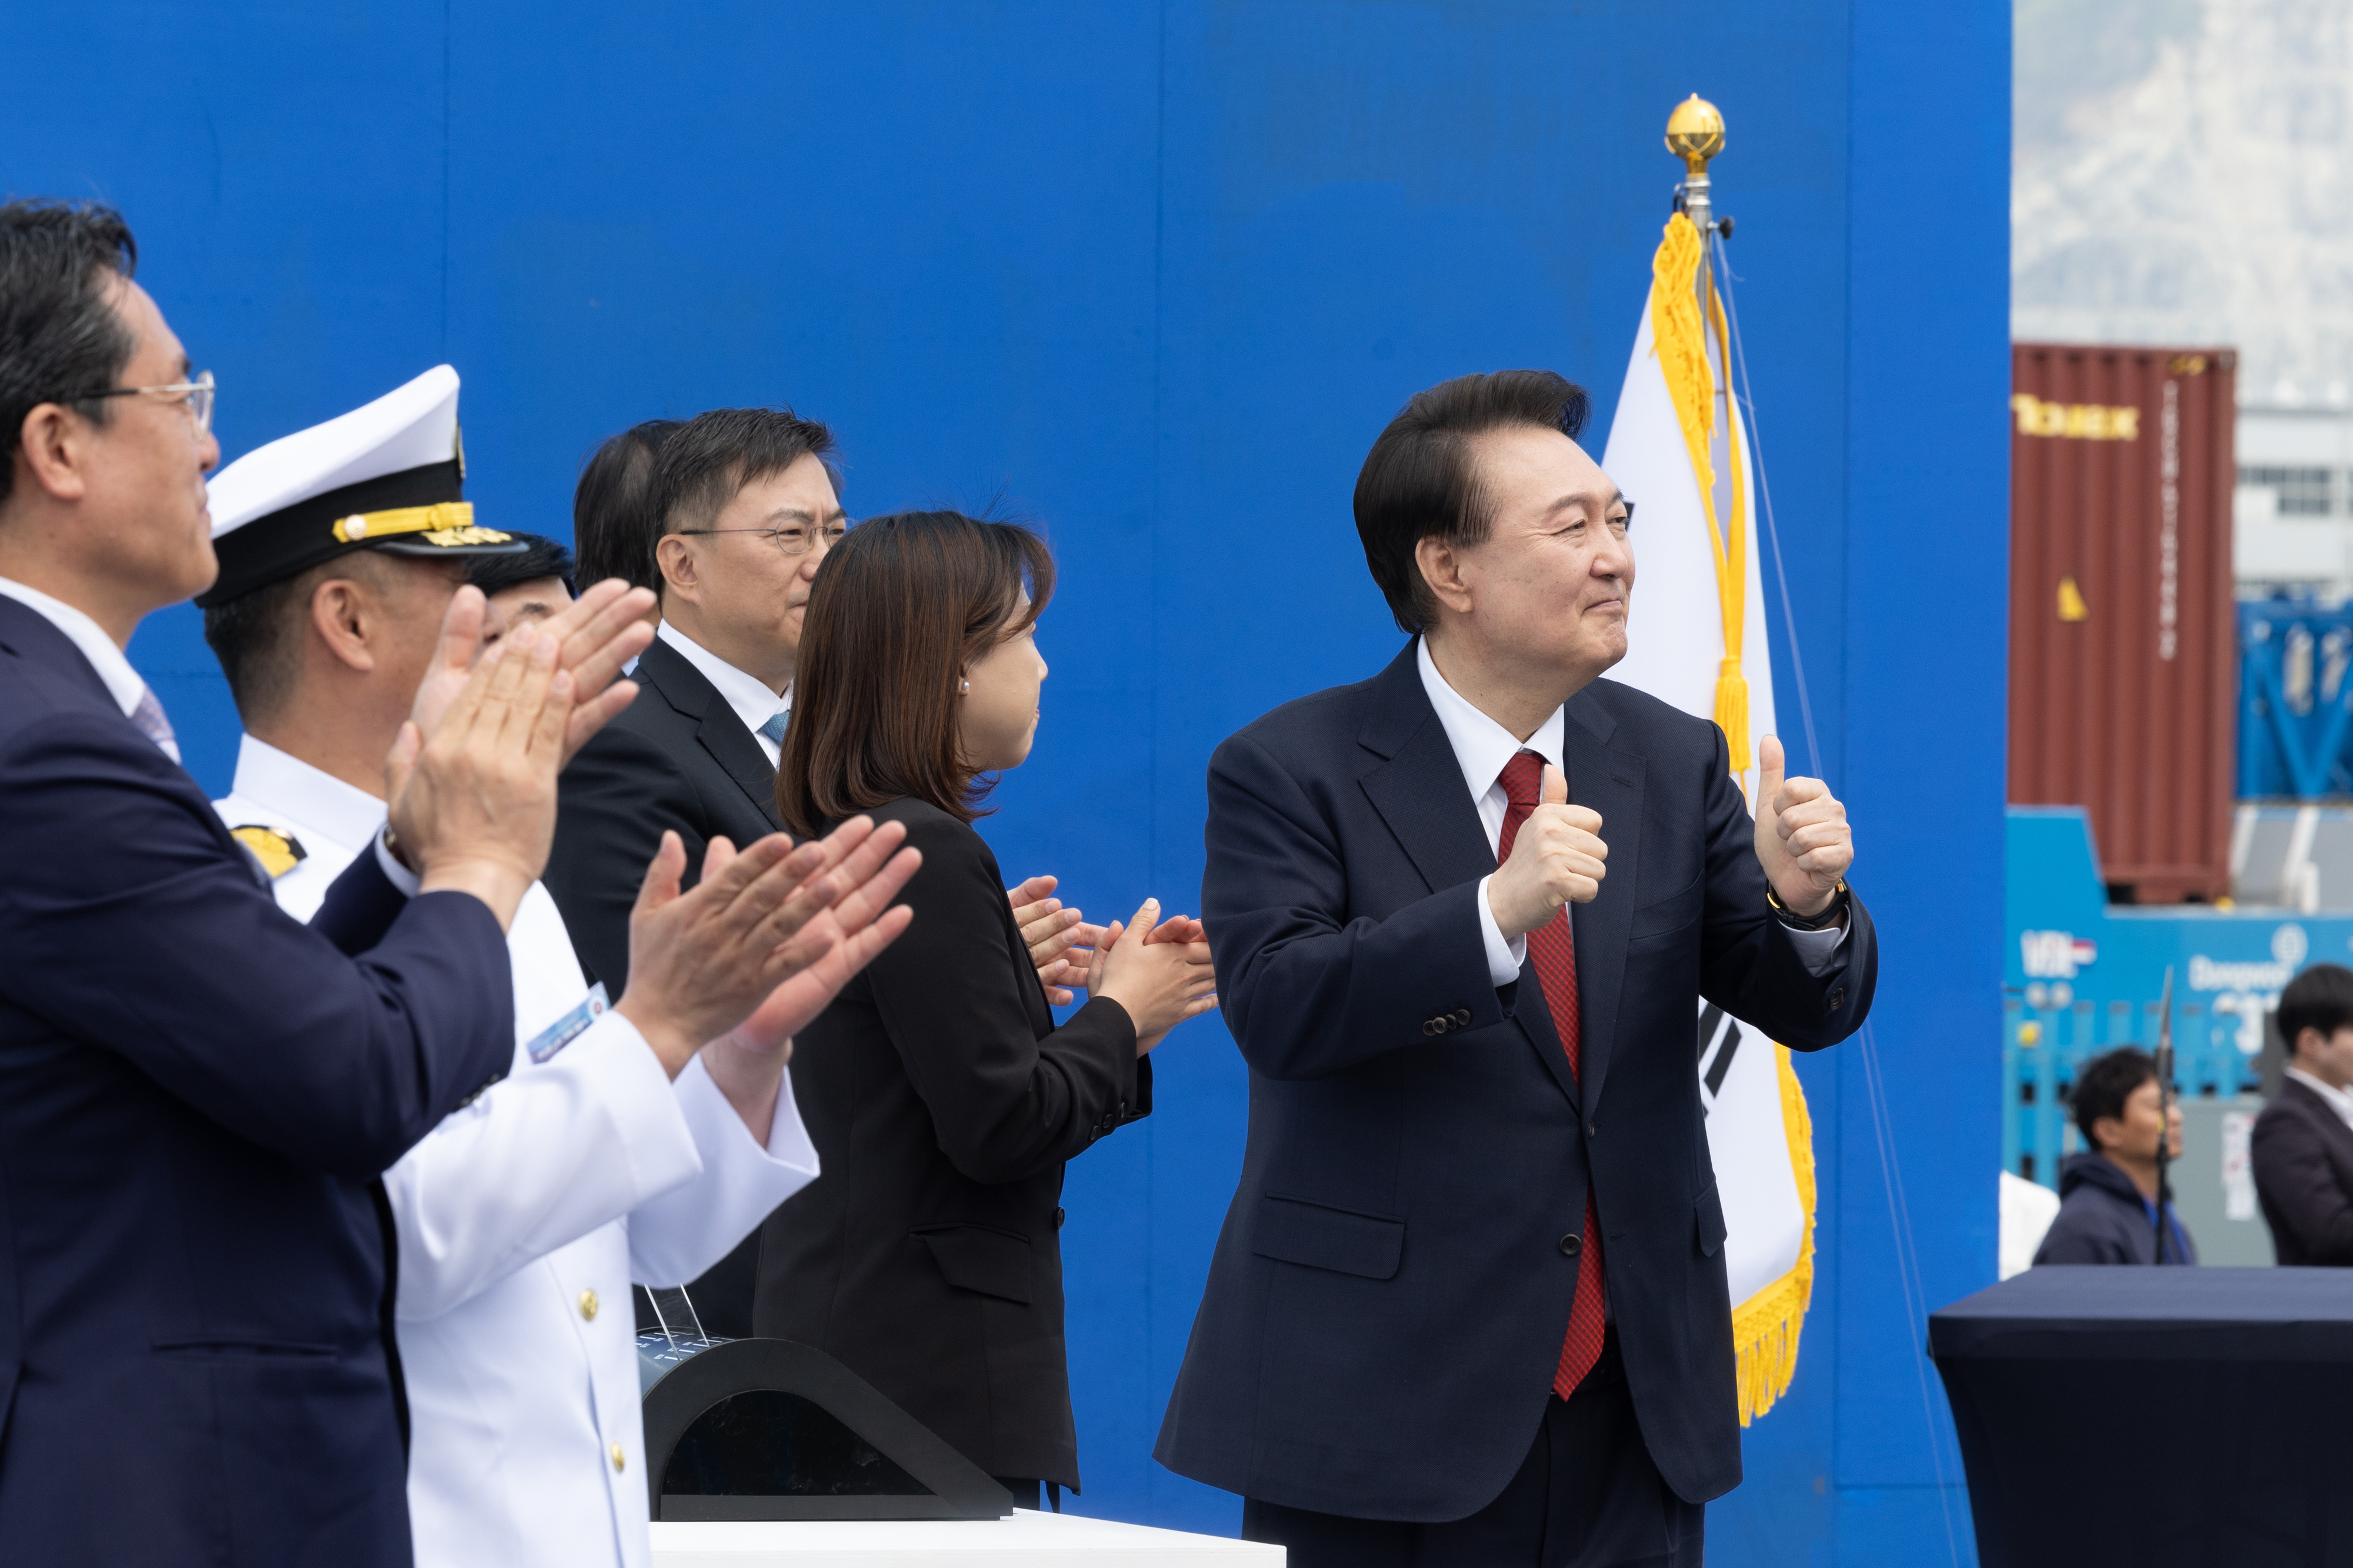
[1155,645,1878,1521]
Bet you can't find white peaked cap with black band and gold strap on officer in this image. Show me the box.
[195,365,527,608]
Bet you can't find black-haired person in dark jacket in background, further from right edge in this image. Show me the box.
[2035,1045,2198,1267]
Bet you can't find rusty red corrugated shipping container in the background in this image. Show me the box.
[2009,343,2238,904]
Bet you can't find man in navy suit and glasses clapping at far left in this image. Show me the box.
[0,202,838,1568]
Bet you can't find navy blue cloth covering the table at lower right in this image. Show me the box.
[1927,1267,2353,1568]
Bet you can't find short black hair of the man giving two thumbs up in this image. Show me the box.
[1355,369,1593,633]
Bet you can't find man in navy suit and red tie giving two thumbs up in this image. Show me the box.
[1158,372,1878,1568]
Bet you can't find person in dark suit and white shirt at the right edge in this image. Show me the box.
[2254,963,2353,1269]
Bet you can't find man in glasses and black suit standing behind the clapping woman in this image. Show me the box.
[546,408,1099,1337]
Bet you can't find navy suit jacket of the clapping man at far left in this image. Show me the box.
[0,598,515,1568]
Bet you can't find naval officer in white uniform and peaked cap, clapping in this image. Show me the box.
[205,367,913,1568]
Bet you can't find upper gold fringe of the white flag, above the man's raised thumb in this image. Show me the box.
[1649,212,1751,777]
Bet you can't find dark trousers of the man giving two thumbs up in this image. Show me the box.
[1242,1328,1706,1568]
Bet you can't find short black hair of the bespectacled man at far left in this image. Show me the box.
[0,200,139,502]
